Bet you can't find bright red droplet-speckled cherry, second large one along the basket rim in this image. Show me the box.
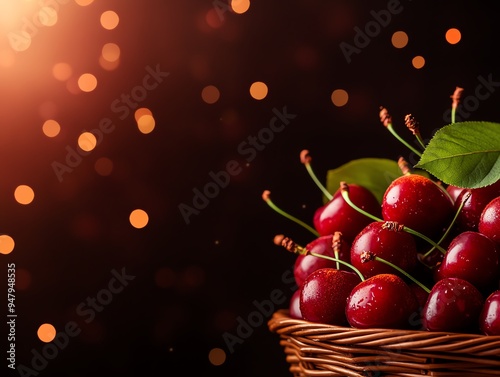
[346,274,419,329]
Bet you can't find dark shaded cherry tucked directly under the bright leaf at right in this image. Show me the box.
[455,180,500,232]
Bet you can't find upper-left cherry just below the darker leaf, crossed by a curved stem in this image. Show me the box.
[313,184,381,241]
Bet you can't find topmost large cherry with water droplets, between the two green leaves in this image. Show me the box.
[382,174,454,238]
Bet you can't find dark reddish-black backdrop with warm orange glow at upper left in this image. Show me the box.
[0,0,500,377]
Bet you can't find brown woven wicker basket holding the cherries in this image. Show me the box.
[268,310,500,377]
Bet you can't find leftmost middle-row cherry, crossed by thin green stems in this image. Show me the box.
[293,234,351,286]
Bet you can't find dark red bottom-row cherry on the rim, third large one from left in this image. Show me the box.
[422,278,484,332]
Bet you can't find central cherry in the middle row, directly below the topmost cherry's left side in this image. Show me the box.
[351,221,418,278]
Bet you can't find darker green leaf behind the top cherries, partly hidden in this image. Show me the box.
[326,157,402,203]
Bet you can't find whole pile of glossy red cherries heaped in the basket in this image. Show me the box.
[270,151,500,335]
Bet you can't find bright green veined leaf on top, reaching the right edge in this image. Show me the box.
[415,122,500,188]
